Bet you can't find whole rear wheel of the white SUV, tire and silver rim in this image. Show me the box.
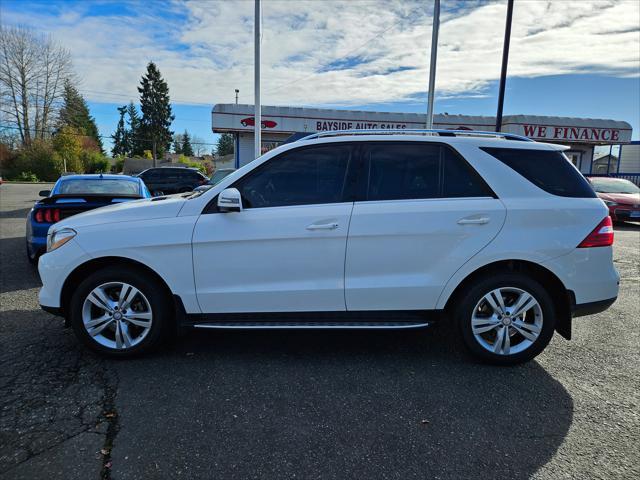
[455,273,555,365]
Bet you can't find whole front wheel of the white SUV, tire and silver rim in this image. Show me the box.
[70,267,172,357]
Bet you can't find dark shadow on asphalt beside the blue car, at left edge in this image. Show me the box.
[0,237,42,293]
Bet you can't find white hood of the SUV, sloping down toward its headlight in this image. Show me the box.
[56,194,186,229]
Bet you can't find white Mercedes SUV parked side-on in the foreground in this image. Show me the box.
[39,131,619,364]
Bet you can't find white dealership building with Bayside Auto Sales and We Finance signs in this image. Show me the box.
[212,104,640,174]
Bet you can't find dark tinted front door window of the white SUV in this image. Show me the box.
[233,145,351,208]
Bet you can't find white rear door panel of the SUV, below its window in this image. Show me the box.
[345,198,505,310]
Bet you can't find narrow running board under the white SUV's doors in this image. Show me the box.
[192,321,431,330]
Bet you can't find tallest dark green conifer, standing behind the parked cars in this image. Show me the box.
[138,62,175,159]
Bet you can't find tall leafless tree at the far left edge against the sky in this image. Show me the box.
[0,25,73,145]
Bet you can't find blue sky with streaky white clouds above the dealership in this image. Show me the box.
[0,0,640,154]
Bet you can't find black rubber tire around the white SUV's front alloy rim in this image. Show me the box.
[69,266,174,358]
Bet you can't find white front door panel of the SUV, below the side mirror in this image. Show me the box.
[193,202,353,313]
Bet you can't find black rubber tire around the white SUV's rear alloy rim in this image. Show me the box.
[454,272,555,365]
